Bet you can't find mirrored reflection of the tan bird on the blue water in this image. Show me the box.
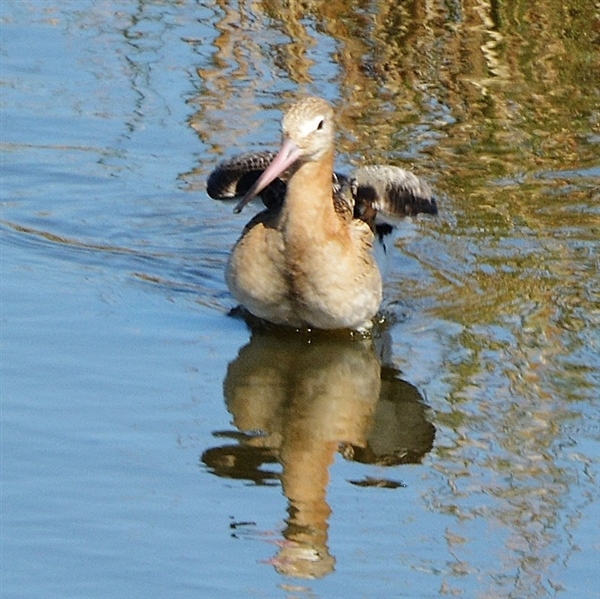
[202,330,435,578]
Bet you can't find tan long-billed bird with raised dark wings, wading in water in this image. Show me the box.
[207,96,437,332]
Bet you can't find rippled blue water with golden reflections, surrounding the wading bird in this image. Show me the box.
[0,0,600,599]
